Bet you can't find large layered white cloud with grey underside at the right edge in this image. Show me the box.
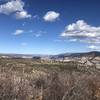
[61,20,100,44]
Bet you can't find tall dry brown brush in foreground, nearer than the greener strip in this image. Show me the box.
[0,57,100,100]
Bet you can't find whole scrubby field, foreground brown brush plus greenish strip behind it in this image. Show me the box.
[0,59,100,100]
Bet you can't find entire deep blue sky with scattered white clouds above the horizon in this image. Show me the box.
[0,0,100,54]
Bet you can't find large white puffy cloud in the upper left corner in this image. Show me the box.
[0,0,31,19]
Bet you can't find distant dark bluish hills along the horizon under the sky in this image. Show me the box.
[0,51,100,59]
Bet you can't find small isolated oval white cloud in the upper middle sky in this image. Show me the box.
[43,11,60,22]
